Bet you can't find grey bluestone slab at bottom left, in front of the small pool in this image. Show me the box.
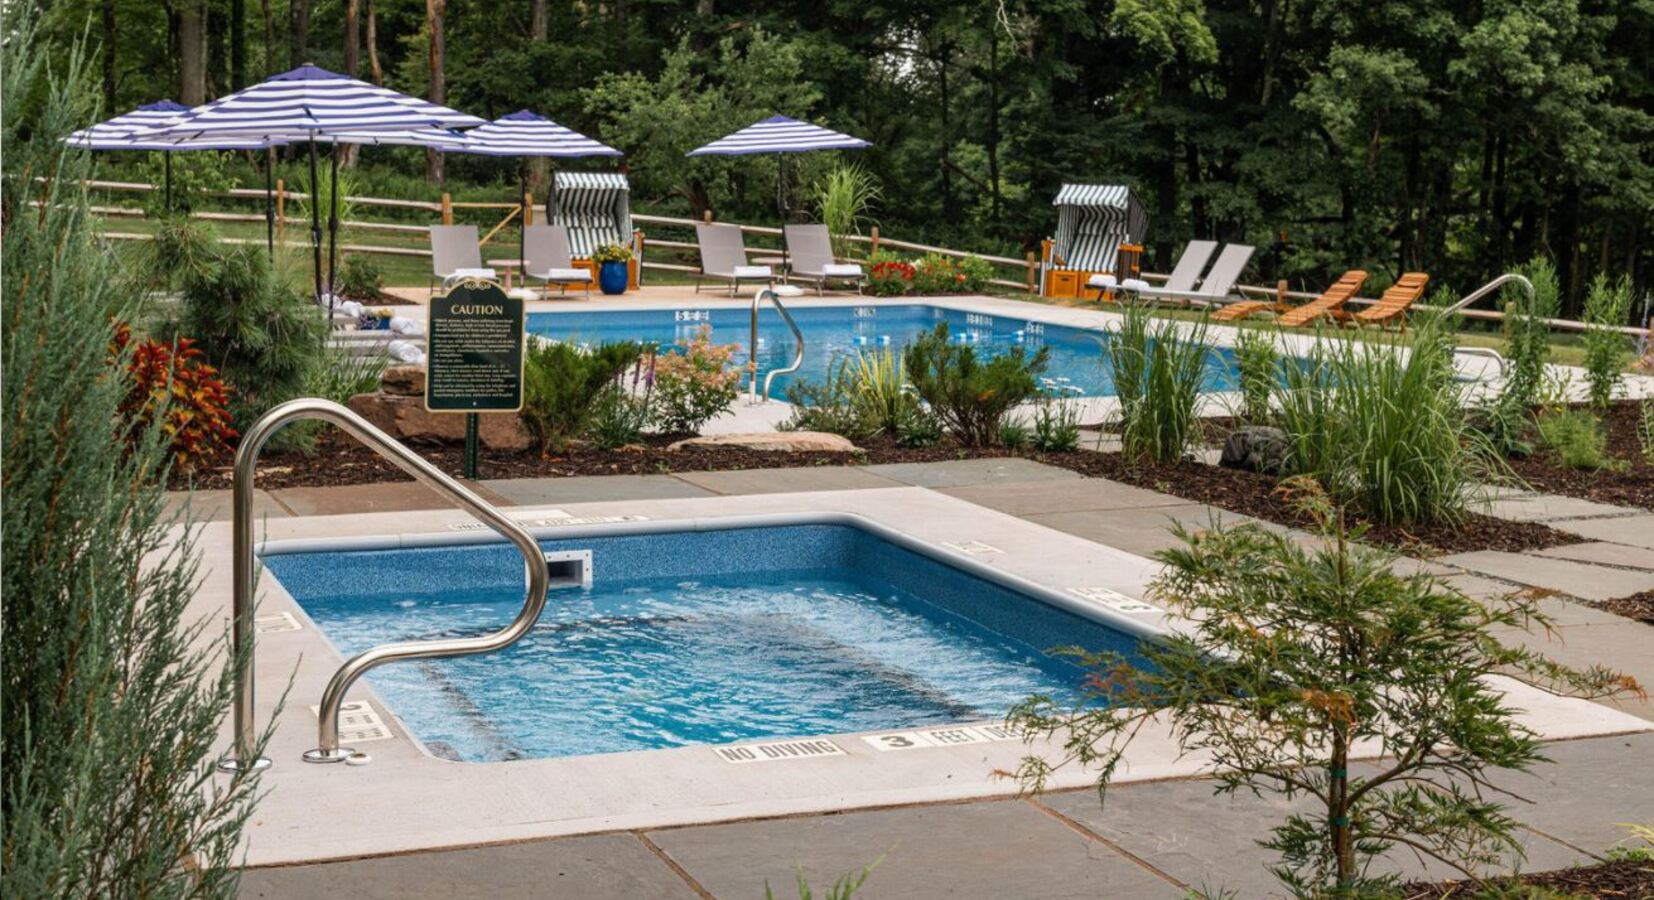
[241,834,698,900]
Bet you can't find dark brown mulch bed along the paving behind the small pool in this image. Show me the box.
[170,432,1575,554]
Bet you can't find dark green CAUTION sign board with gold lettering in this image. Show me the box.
[425,280,524,412]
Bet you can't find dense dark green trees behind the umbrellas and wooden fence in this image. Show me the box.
[25,0,1654,314]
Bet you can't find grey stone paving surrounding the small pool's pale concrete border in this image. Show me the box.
[161,460,1654,898]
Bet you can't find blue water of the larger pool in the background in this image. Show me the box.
[528,304,1239,397]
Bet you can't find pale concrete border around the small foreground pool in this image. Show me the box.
[210,488,1649,865]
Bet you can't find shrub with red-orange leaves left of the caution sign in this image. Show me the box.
[111,324,237,468]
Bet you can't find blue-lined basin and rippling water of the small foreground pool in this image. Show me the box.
[265,524,1136,761]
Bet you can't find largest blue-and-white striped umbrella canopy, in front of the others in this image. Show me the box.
[134,66,483,139]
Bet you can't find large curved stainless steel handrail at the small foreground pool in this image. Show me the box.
[218,397,549,771]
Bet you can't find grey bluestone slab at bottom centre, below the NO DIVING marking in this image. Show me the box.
[648,801,1183,900]
